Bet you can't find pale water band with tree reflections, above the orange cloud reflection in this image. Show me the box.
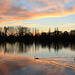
[0,42,75,57]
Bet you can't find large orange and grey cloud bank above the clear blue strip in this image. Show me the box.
[0,0,75,23]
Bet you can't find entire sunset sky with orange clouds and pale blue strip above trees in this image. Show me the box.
[0,0,75,31]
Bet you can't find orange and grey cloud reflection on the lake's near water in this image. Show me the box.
[0,52,75,75]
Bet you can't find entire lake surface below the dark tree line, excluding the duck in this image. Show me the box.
[0,42,75,75]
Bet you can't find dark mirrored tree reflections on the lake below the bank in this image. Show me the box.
[0,42,75,56]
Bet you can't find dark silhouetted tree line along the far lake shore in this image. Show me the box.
[0,26,75,42]
